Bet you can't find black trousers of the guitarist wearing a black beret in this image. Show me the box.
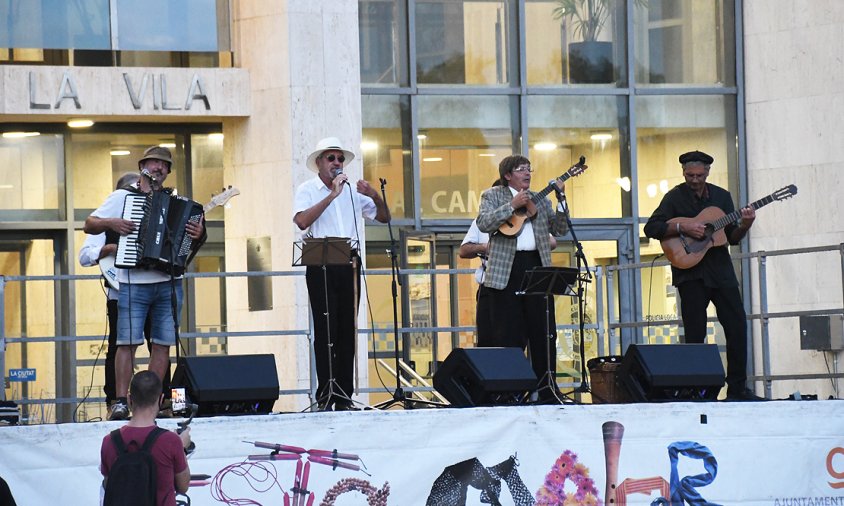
[677,280,747,393]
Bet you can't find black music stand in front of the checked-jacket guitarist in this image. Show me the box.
[518,266,578,404]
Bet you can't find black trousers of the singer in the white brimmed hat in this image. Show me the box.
[305,260,360,402]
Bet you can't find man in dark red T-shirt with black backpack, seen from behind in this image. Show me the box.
[100,371,190,506]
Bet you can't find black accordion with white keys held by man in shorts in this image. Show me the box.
[114,191,202,276]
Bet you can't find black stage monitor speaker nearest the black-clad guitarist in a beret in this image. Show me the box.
[617,344,724,402]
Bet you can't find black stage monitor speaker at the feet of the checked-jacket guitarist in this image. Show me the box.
[434,348,537,408]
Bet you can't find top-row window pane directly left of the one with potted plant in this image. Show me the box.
[416,0,511,86]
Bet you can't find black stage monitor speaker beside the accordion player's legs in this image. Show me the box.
[171,355,278,416]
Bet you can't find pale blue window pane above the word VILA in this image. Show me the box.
[115,0,229,51]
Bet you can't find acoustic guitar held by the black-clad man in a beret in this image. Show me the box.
[660,184,797,269]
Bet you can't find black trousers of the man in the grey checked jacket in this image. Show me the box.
[478,251,557,385]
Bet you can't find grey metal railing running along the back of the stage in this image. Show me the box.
[0,243,844,422]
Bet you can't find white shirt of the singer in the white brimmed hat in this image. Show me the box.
[293,176,378,241]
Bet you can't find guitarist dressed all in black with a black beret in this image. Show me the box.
[645,151,764,401]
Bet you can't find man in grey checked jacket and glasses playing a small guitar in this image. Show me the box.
[477,155,568,402]
